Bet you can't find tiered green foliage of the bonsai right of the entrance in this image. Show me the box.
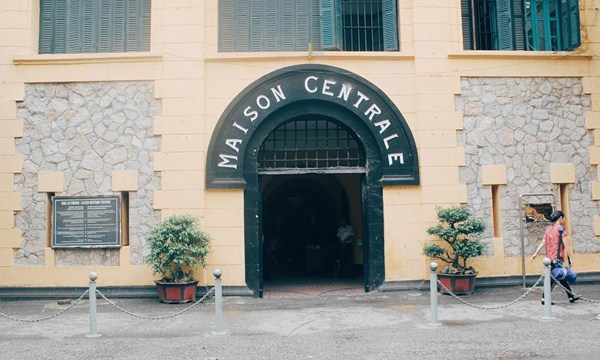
[423,205,485,274]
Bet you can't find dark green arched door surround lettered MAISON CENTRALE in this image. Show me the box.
[207,65,419,296]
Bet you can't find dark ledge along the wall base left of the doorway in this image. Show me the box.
[0,286,254,300]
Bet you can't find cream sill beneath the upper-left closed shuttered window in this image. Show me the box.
[12,52,162,65]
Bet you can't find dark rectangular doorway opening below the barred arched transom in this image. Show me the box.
[260,174,364,296]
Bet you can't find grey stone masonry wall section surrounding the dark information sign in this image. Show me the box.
[15,82,160,266]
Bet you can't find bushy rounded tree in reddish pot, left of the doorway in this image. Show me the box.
[146,215,210,303]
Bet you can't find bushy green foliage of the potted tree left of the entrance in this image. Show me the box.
[146,215,210,283]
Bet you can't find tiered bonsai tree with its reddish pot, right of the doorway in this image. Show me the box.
[423,205,486,295]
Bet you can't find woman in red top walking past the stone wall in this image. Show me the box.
[531,210,579,304]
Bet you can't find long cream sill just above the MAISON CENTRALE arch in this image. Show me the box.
[205,51,415,62]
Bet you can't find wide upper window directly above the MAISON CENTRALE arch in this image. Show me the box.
[219,0,398,52]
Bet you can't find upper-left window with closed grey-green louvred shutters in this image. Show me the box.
[39,0,151,54]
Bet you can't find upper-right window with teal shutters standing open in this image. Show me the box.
[461,0,581,51]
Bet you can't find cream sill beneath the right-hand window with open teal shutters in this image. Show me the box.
[448,50,592,60]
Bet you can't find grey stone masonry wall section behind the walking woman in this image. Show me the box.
[456,78,600,256]
